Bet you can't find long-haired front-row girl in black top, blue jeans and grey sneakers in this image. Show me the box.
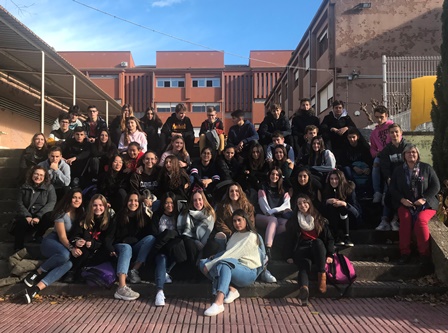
[111,192,157,301]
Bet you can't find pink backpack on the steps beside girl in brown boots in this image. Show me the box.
[325,252,356,297]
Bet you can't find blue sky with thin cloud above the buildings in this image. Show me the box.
[0,0,322,65]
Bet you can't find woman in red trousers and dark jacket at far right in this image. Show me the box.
[390,145,440,264]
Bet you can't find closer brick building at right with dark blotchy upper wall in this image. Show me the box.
[266,0,443,127]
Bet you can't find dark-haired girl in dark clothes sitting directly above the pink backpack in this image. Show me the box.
[322,170,361,247]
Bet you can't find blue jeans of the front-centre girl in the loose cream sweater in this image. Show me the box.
[199,259,258,296]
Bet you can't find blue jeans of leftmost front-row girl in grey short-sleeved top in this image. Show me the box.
[40,232,72,286]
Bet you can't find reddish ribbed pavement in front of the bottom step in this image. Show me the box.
[0,291,448,333]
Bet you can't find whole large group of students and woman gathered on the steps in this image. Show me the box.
[15,99,439,315]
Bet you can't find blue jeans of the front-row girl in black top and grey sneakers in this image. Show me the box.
[114,235,156,275]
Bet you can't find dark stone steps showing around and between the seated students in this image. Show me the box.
[0,150,447,298]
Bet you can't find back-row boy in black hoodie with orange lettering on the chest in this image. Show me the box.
[160,103,194,155]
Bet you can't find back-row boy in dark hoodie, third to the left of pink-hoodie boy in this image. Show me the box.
[258,104,291,146]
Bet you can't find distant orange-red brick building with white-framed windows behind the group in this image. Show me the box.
[59,51,292,127]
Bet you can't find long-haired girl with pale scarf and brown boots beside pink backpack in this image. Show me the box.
[283,194,334,306]
